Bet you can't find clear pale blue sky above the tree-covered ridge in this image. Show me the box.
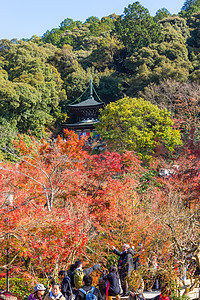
[0,0,184,39]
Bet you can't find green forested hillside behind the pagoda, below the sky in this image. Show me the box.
[0,0,200,143]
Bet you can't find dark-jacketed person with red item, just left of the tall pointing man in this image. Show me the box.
[103,265,120,300]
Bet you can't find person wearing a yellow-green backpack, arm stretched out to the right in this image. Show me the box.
[71,260,100,290]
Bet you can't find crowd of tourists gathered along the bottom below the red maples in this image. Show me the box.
[14,244,171,300]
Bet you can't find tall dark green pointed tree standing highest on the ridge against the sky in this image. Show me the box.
[115,2,162,52]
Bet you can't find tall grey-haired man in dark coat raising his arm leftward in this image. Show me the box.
[112,244,134,296]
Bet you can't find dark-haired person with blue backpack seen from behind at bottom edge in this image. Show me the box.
[75,275,103,300]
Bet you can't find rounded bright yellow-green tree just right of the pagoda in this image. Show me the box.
[96,98,181,160]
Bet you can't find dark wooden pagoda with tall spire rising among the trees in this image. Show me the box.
[63,79,104,137]
